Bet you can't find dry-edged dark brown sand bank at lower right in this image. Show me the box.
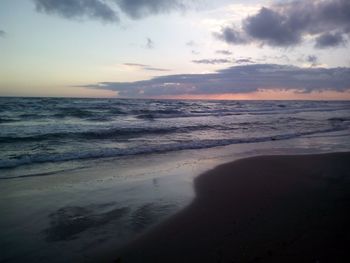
[104,153,350,263]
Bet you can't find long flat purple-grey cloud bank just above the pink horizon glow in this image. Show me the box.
[84,64,350,97]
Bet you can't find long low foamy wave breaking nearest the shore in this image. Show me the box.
[0,126,346,169]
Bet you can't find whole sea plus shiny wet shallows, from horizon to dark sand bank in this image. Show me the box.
[0,97,350,263]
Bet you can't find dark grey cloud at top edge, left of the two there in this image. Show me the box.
[33,0,119,22]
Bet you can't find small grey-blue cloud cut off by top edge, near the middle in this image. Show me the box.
[115,0,185,19]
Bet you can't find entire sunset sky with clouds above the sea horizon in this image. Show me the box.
[0,0,350,100]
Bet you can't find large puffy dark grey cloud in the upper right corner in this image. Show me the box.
[214,0,350,48]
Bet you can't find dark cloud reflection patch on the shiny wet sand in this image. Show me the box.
[43,202,176,242]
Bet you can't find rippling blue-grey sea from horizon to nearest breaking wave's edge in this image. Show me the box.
[0,98,350,177]
